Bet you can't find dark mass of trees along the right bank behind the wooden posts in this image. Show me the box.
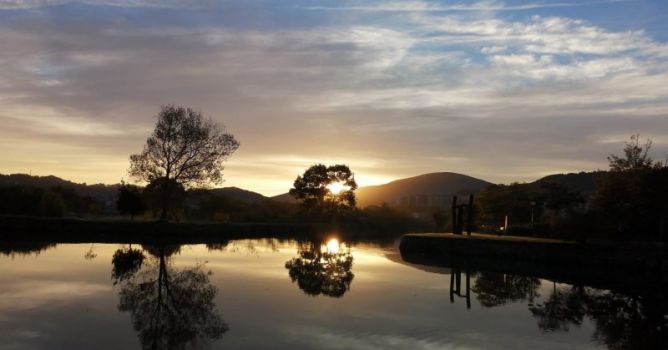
[476,135,668,241]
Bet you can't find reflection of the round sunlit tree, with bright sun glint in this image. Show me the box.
[285,239,355,298]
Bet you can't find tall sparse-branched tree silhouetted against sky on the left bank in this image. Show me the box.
[128,105,239,219]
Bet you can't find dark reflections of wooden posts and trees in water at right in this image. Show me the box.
[450,268,668,349]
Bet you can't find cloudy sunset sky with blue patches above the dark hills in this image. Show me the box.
[0,0,668,195]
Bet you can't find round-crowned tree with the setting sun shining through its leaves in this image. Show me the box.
[290,164,357,216]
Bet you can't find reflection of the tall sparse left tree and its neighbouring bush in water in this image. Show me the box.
[112,246,228,349]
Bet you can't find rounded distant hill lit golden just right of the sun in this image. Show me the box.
[357,172,491,208]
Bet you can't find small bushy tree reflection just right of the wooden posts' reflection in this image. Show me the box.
[471,272,540,307]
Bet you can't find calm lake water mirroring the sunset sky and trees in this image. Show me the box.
[0,239,667,349]
